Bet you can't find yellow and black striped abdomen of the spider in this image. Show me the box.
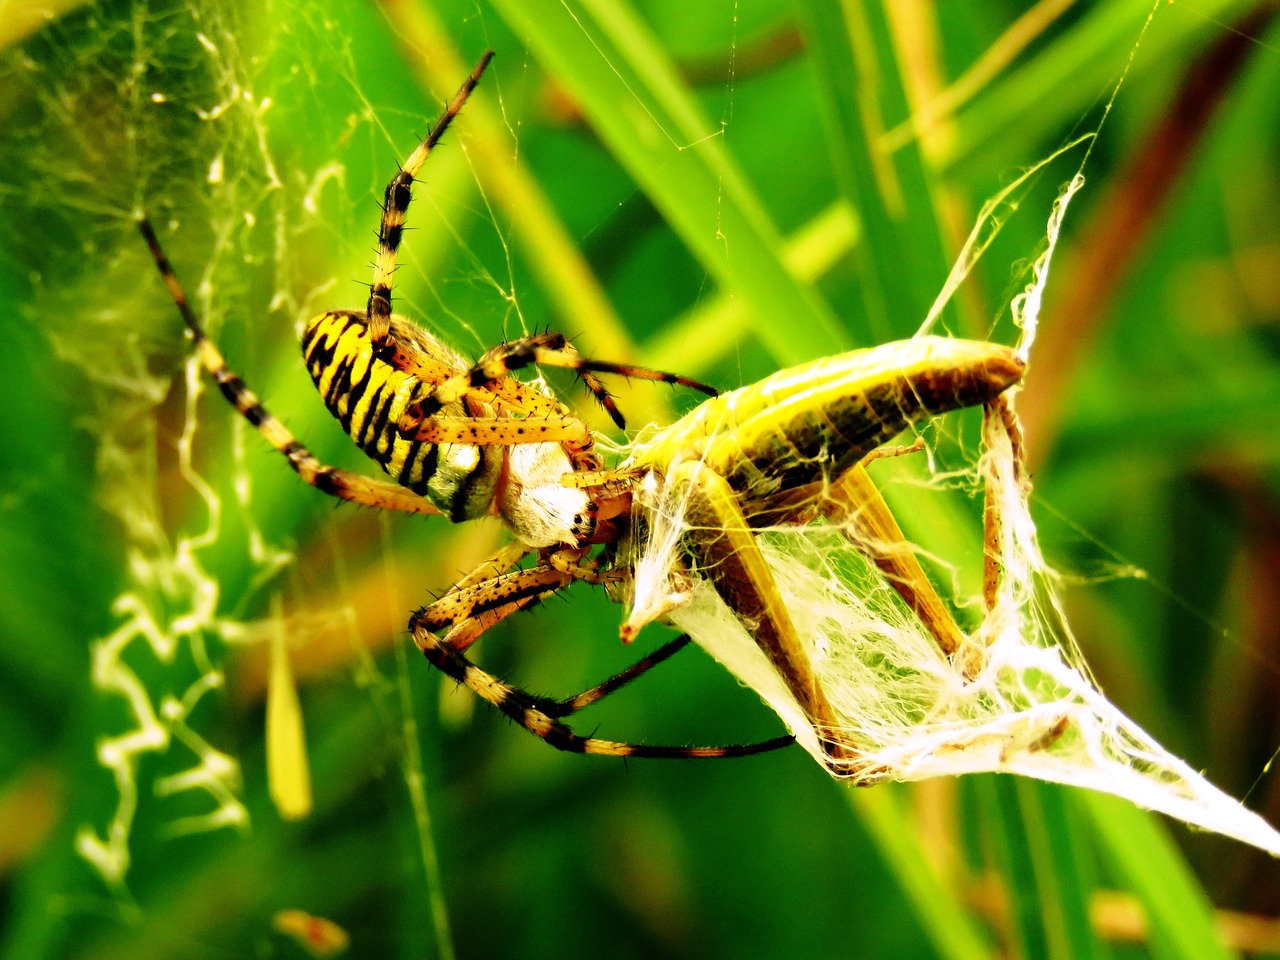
[302,310,500,521]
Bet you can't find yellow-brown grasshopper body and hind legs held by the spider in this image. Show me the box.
[616,337,1024,782]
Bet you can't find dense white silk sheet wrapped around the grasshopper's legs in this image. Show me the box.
[623,176,1280,856]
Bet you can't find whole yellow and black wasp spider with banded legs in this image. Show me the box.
[138,51,792,758]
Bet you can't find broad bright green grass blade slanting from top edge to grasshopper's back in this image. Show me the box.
[481,0,850,364]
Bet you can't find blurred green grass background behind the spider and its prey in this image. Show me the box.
[0,0,1280,957]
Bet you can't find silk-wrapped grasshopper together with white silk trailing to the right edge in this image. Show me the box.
[614,337,1280,855]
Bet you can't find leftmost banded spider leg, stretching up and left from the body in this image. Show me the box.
[138,218,440,515]
